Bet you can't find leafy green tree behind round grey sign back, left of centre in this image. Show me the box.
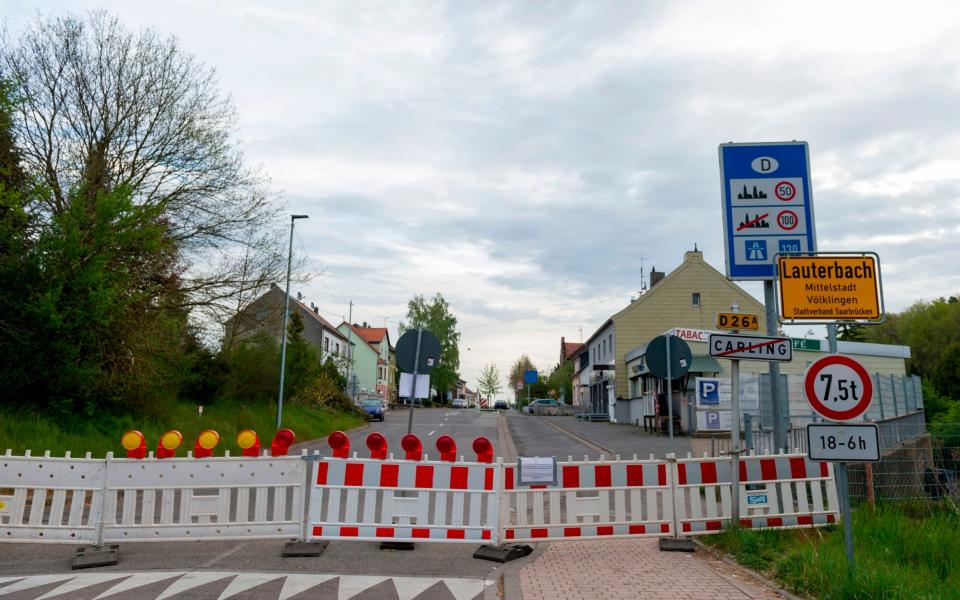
[400,293,460,401]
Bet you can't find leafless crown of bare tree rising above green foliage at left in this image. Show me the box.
[0,11,284,328]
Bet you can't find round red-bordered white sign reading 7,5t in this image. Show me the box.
[803,354,873,421]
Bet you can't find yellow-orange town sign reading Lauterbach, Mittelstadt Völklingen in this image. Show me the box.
[777,253,884,323]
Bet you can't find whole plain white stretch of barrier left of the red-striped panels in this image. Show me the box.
[0,451,306,545]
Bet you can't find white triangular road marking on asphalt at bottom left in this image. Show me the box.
[0,571,490,600]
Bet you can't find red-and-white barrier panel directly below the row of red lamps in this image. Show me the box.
[307,455,501,544]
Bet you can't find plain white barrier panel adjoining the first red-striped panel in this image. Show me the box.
[101,454,307,543]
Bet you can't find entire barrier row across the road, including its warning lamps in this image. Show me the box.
[0,430,839,545]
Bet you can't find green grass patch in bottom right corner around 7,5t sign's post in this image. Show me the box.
[702,502,960,600]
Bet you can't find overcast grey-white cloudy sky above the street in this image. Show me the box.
[0,0,960,394]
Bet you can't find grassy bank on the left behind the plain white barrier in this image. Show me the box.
[0,402,364,458]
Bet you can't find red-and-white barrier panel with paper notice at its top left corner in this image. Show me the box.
[500,456,673,542]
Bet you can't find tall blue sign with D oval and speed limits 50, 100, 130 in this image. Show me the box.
[720,142,817,281]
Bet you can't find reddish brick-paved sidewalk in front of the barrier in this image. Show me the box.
[511,538,781,600]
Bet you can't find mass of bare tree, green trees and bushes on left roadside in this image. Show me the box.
[0,12,343,420]
